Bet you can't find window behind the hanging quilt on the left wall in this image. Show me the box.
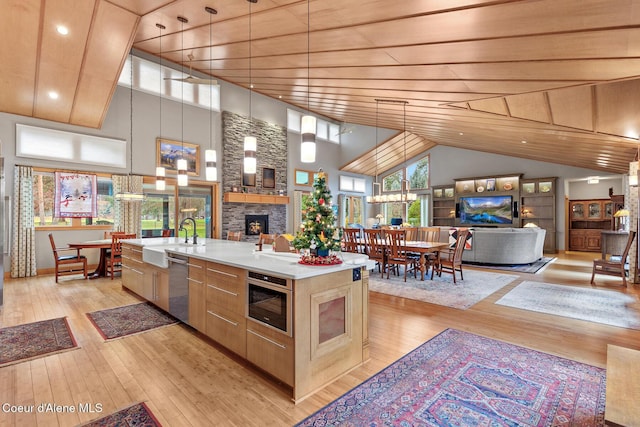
[33,170,113,228]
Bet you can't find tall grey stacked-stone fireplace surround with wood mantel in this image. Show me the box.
[221,111,287,242]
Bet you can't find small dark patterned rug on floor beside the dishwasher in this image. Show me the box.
[87,302,178,340]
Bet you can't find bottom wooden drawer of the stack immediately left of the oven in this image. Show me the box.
[206,303,247,358]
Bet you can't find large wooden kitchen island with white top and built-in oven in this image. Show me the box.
[122,238,369,402]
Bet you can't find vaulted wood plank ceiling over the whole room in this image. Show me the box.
[0,0,640,175]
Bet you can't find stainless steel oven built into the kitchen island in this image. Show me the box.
[247,271,293,336]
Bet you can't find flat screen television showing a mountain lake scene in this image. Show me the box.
[459,196,513,225]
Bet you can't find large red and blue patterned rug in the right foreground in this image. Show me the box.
[297,329,606,427]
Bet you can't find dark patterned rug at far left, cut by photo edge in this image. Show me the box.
[0,317,78,367]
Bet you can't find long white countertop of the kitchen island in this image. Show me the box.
[126,237,371,279]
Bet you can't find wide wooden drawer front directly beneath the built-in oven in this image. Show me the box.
[246,320,294,386]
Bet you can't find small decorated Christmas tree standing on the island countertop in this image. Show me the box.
[292,169,341,255]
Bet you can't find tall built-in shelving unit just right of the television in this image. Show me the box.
[520,177,557,253]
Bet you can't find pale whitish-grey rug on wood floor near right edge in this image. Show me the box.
[496,281,640,329]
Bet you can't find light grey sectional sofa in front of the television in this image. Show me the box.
[440,227,546,264]
